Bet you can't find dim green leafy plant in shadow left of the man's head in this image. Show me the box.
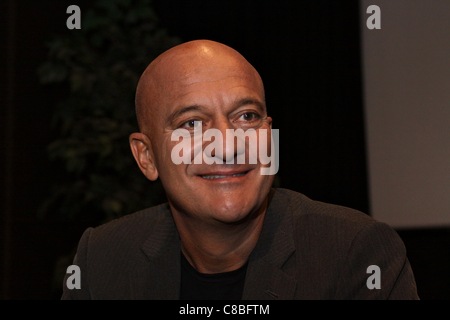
[37,0,180,221]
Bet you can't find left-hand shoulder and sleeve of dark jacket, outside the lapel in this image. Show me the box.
[62,204,176,299]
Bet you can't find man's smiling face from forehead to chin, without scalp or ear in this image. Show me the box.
[132,50,273,223]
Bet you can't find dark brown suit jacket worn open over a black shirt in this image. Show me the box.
[62,189,418,300]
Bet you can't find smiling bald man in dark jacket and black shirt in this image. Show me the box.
[62,40,418,300]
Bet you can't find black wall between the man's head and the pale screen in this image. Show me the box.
[155,0,368,212]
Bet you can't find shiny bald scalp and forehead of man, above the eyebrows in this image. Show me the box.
[135,40,264,137]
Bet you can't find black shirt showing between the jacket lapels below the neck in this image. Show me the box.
[180,253,248,300]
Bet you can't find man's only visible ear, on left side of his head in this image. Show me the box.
[130,133,158,181]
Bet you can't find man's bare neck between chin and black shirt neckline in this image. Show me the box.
[171,199,268,273]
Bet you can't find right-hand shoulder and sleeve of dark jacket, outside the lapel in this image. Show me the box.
[270,189,417,299]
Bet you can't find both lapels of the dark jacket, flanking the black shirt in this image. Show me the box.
[135,189,297,300]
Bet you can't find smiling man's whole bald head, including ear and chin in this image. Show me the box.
[130,40,273,223]
